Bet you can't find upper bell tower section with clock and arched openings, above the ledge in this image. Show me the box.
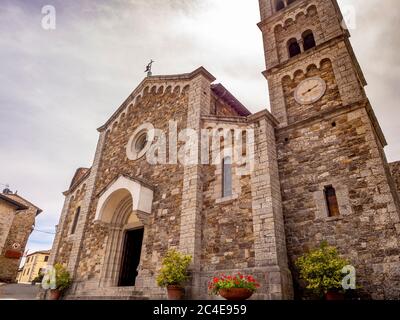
[259,0,366,126]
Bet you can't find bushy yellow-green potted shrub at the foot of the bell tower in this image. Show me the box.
[295,242,349,300]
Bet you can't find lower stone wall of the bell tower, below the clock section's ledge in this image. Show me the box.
[277,104,400,299]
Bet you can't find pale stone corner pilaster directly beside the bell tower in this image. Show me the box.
[251,117,293,299]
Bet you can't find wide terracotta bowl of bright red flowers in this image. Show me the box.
[208,272,260,301]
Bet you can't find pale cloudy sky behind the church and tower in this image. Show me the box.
[0,0,400,252]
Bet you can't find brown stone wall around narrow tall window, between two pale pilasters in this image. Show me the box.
[201,120,255,272]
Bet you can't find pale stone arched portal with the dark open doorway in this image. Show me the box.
[95,176,153,288]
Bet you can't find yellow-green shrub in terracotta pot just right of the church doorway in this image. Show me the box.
[157,250,192,300]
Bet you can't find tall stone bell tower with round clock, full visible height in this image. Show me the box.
[258,0,400,299]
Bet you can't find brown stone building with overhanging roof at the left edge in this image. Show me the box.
[0,189,42,282]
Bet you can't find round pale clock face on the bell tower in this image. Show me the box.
[294,77,326,104]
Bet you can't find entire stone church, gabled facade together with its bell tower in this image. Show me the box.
[49,0,400,299]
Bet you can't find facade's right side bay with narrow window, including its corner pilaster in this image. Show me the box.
[200,112,292,299]
